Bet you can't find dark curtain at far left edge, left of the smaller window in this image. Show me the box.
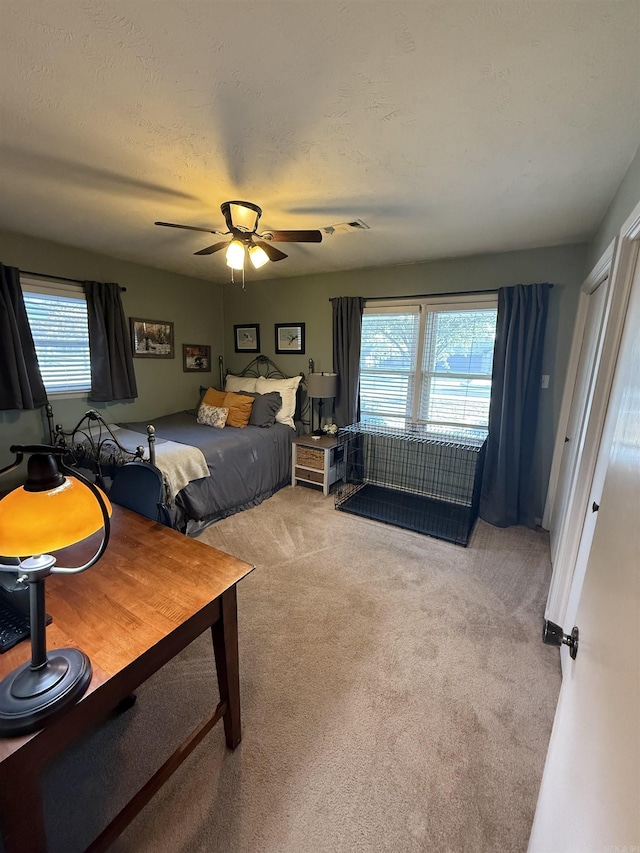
[0,264,47,410]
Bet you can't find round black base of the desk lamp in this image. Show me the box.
[0,649,92,737]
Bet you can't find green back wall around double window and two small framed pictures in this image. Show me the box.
[224,238,587,517]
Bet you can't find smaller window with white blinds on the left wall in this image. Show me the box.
[21,277,91,394]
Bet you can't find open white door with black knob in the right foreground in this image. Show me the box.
[529,250,640,853]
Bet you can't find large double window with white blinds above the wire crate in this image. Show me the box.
[360,294,497,432]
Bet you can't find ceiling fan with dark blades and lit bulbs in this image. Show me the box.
[155,201,322,270]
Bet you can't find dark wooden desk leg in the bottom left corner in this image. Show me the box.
[0,771,47,853]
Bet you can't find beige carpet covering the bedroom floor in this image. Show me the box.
[40,487,560,853]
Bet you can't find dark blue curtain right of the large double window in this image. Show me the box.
[480,284,551,527]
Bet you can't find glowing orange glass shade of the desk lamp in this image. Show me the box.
[0,477,111,557]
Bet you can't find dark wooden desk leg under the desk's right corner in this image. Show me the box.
[211,584,241,749]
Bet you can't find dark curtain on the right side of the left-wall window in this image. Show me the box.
[83,281,138,403]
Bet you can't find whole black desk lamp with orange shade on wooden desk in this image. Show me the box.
[0,445,111,737]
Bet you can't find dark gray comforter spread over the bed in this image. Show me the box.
[121,412,295,533]
